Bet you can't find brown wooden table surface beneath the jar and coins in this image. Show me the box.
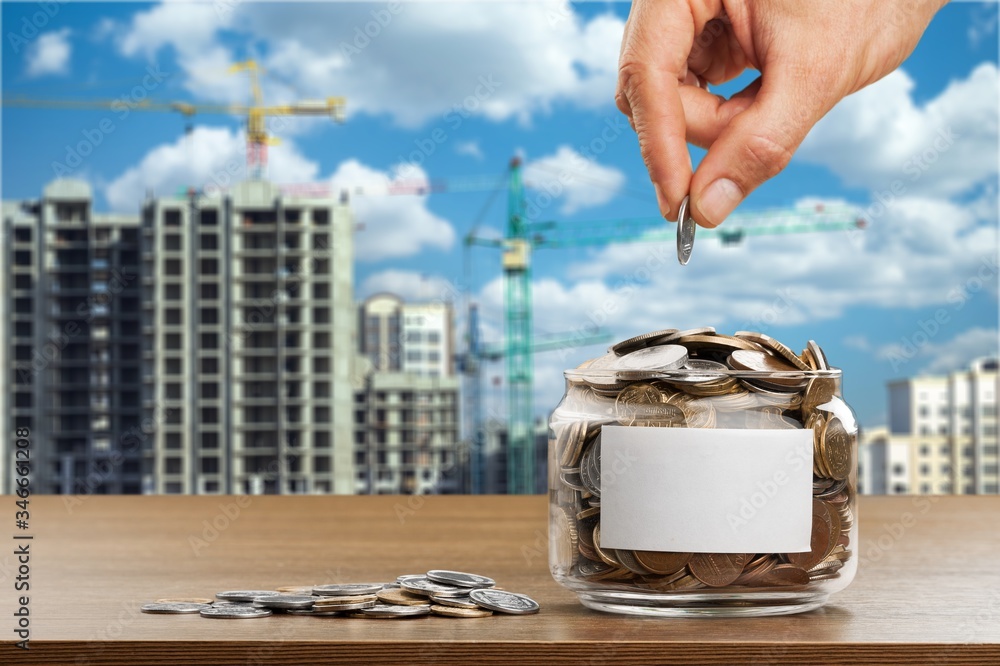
[0,496,1000,666]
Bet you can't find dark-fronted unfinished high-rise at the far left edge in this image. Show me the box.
[0,180,150,494]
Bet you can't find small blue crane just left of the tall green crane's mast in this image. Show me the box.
[457,303,611,495]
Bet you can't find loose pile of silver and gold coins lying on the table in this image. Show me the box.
[142,569,539,620]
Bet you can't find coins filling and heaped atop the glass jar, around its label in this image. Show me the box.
[549,328,856,592]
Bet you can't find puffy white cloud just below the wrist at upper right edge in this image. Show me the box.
[797,62,1000,196]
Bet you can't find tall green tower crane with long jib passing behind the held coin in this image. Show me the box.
[465,158,865,494]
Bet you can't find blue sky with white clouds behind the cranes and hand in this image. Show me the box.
[0,0,998,425]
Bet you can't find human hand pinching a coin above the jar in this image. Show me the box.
[615,0,947,227]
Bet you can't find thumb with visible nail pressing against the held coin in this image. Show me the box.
[691,68,832,227]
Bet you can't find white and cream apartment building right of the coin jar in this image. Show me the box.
[859,358,1000,495]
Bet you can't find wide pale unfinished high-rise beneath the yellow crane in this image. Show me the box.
[142,181,355,494]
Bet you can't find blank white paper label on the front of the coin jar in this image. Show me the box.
[600,426,813,553]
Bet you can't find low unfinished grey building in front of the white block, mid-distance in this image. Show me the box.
[354,358,468,494]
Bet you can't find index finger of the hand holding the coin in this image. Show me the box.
[618,0,695,219]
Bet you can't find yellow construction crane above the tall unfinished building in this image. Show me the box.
[3,60,346,180]
